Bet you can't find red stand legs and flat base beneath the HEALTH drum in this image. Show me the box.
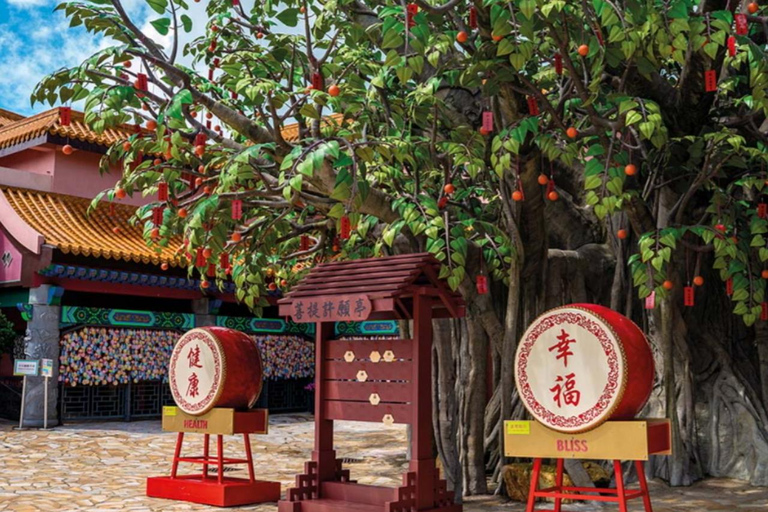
[147,411,280,507]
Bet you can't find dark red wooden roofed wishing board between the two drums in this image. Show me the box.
[278,253,465,512]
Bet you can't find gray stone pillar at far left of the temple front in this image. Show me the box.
[21,285,61,428]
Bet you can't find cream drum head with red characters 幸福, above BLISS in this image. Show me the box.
[515,306,626,433]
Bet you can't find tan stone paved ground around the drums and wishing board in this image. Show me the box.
[0,416,768,512]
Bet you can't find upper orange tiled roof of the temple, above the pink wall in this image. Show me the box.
[0,108,135,149]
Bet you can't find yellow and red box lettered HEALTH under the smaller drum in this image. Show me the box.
[163,406,269,435]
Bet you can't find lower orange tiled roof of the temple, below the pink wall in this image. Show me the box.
[2,187,181,266]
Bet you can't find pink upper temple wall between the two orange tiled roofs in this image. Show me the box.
[0,144,150,206]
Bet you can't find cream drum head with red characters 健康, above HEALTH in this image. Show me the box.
[168,329,226,415]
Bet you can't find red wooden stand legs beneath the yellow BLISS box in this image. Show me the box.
[525,458,653,512]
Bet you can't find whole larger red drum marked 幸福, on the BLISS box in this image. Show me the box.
[515,304,654,433]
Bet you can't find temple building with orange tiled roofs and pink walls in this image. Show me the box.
[0,108,376,427]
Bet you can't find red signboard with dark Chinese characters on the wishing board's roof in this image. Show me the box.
[291,295,371,323]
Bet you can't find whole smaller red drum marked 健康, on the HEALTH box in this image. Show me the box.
[168,327,263,415]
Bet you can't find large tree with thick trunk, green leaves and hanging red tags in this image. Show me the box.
[33,0,768,495]
